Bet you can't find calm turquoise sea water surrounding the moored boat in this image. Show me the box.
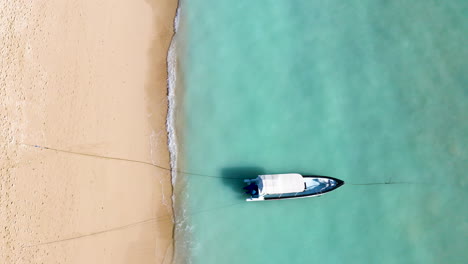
[175,0,468,264]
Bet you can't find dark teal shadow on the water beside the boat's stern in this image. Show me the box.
[221,166,265,199]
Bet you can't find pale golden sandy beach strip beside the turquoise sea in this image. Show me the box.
[0,0,177,264]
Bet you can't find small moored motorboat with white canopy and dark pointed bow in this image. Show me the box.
[244,173,344,202]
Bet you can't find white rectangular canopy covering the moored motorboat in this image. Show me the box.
[257,173,305,195]
